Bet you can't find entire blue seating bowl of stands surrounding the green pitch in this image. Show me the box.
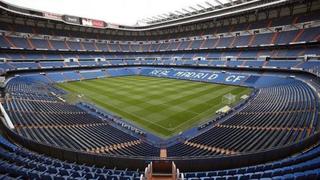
[0,1,320,180]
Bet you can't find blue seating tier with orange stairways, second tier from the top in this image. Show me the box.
[0,27,320,52]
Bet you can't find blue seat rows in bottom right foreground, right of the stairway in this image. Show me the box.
[183,146,320,180]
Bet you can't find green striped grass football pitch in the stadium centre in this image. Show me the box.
[58,76,251,138]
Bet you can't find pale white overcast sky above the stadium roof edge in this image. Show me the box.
[3,0,232,25]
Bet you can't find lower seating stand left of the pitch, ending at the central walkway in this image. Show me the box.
[5,76,159,156]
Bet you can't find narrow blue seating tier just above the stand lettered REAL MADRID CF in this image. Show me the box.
[0,54,320,76]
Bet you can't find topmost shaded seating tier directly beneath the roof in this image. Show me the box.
[0,11,319,41]
